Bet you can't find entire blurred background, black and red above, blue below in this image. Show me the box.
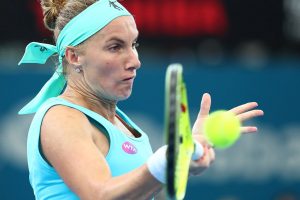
[0,0,300,200]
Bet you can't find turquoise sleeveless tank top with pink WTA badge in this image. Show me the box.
[27,97,152,200]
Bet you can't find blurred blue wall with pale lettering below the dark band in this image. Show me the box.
[0,57,300,200]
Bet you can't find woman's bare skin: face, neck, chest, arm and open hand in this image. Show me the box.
[41,16,262,200]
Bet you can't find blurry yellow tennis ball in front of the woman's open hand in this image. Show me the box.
[204,110,241,149]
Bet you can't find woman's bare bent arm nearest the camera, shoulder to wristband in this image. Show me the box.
[41,106,162,200]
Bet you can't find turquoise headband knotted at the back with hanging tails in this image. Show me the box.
[19,0,131,114]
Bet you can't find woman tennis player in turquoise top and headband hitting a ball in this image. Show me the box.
[20,0,262,199]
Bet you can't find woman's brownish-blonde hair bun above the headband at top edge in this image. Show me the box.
[41,0,67,31]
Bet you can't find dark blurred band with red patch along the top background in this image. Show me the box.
[0,0,286,48]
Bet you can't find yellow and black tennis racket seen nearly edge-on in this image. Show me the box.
[164,64,203,199]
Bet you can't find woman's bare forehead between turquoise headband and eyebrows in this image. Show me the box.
[95,16,138,39]
